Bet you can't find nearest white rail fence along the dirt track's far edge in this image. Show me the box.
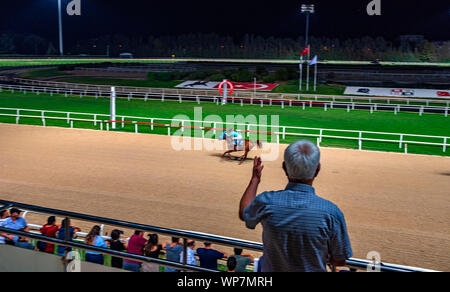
[0,108,450,153]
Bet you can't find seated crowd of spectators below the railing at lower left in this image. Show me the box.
[0,208,253,272]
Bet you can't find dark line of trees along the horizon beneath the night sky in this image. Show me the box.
[0,33,450,61]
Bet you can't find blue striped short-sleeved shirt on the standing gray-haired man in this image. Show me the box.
[244,183,353,272]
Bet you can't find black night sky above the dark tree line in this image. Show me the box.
[0,0,450,42]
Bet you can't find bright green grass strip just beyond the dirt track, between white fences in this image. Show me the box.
[0,91,450,156]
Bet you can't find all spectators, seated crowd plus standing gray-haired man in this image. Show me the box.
[0,140,352,272]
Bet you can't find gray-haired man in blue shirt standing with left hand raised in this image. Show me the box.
[239,140,352,272]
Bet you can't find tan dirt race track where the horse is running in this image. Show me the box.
[0,124,450,271]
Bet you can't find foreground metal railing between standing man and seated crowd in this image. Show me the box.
[0,200,434,272]
